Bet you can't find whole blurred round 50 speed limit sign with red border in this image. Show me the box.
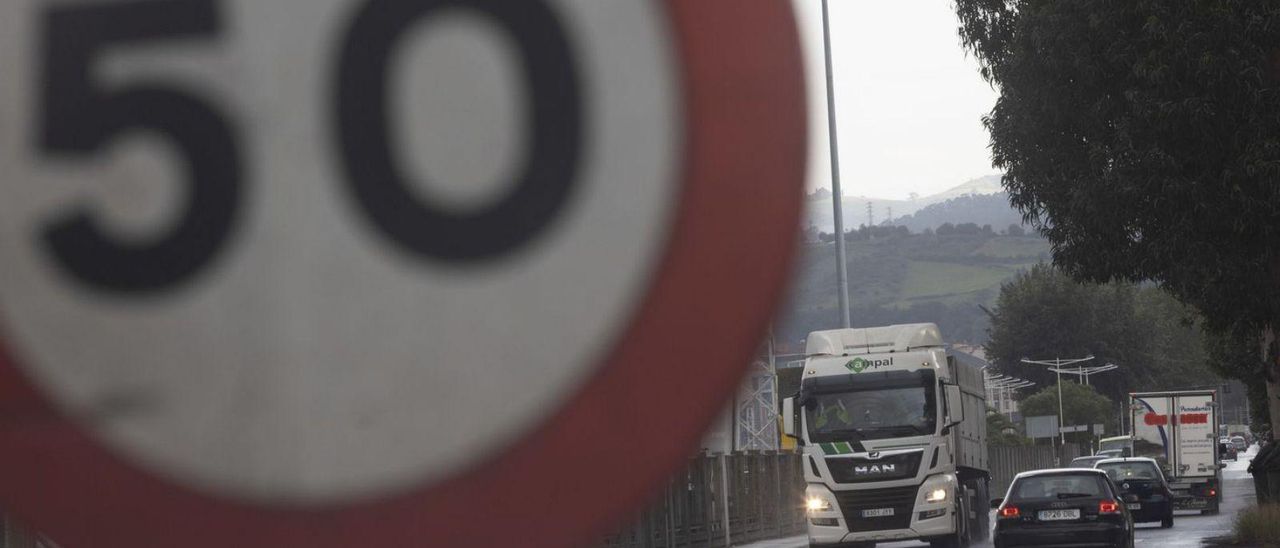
[0,0,805,547]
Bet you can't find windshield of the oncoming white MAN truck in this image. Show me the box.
[805,369,937,443]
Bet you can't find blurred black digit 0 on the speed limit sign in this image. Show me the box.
[334,0,582,262]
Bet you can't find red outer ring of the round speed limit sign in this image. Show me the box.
[0,0,806,548]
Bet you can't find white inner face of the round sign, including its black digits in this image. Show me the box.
[0,0,681,503]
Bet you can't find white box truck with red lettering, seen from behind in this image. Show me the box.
[1129,391,1222,513]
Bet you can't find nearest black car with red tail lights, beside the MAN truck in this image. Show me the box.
[991,469,1133,548]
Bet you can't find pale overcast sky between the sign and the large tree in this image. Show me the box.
[794,0,996,198]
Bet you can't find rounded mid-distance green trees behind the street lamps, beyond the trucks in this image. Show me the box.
[986,264,1219,402]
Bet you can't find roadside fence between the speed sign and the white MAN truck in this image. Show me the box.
[603,452,805,548]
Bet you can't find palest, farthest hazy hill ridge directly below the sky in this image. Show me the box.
[805,175,1009,233]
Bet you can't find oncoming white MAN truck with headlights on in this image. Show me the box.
[782,324,991,547]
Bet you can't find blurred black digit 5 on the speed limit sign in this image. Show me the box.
[40,0,242,293]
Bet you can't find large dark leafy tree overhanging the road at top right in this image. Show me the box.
[956,0,1280,434]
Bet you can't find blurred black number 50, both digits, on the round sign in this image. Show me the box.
[40,0,582,293]
